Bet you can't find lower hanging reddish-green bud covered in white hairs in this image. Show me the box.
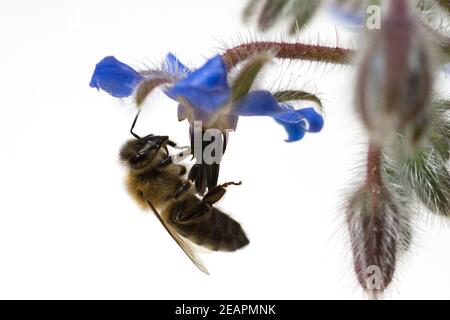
[347,183,406,297]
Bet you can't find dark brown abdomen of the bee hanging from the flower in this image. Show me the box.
[168,199,249,251]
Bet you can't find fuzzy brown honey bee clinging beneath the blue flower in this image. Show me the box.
[120,116,249,274]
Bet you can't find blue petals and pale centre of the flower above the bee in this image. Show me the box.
[90,53,323,142]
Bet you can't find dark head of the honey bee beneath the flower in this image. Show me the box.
[120,134,169,171]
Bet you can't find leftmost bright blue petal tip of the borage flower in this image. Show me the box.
[89,56,143,98]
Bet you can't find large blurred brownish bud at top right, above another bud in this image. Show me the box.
[356,0,432,146]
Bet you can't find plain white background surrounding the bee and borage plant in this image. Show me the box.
[0,0,450,299]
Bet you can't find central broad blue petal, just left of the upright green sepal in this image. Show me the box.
[165,55,231,112]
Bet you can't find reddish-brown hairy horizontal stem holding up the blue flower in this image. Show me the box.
[223,41,354,70]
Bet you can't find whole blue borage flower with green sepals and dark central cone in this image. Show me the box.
[90,53,323,192]
